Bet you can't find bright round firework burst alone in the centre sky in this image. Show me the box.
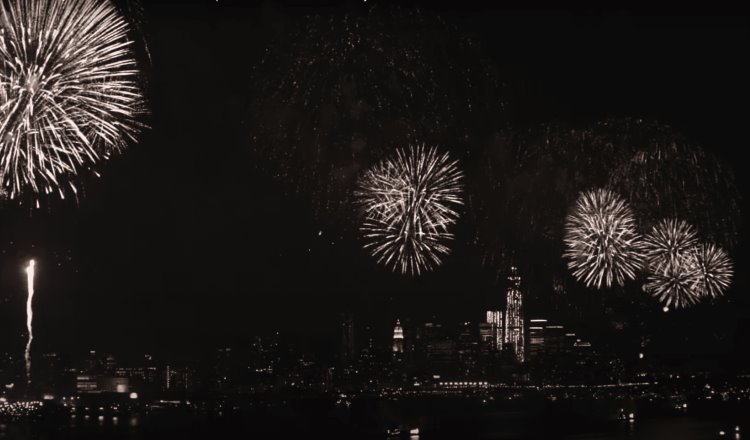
[355,145,463,274]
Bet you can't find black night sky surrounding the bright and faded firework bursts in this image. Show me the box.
[0,2,750,364]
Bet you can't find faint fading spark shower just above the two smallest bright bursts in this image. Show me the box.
[609,120,742,249]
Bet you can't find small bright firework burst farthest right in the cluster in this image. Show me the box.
[693,244,734,298]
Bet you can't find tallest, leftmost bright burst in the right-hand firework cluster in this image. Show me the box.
[563,189,643,288]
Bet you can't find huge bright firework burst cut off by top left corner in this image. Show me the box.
[0,0,143,198]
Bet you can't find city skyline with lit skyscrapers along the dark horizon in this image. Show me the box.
[4,267,747,378]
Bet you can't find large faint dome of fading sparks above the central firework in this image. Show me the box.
[253,9,507,223]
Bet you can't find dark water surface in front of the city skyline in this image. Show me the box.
[0,398,750,440]
